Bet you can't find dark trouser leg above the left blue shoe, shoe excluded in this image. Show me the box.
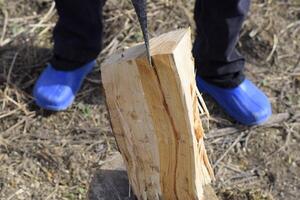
[50,0,105,70]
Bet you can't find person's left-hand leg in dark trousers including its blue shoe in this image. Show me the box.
[33,0,105,111]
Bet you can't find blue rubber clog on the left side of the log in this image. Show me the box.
[33,61,96,111]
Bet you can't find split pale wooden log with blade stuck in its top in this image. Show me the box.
[102,29,213,200]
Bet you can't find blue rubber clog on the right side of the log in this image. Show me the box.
[197,77,272,125]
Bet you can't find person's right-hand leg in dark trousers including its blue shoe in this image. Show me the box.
[193,0,272,125]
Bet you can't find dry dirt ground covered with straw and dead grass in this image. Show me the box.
[0,0,300,200]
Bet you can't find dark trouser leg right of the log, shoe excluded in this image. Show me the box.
[193,0,250,88]
